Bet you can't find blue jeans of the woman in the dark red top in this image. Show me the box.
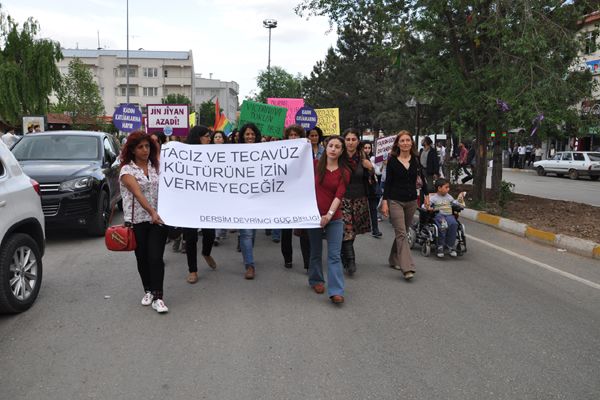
[307,219,344,297]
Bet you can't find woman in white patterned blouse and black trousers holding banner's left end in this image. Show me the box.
[119,131,169,313]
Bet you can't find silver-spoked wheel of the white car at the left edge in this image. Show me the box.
[0,233,42,314]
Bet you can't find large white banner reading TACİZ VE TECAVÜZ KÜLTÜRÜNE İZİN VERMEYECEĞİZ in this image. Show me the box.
[158,139,321,229]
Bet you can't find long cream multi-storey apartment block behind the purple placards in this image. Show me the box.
[52,49,195,116]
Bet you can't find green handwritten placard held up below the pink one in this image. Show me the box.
[238,100,287,138]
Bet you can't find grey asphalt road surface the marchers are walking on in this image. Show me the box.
[0,219,600,400]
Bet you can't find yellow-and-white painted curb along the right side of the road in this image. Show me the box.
[461,208,600,259]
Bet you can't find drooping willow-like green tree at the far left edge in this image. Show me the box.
[0,6,62,126]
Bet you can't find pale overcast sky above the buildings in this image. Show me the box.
[0,0,337,101]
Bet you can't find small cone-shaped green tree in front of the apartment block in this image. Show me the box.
[51,58,104,126]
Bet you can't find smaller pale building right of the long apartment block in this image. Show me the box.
[194,74,240,123]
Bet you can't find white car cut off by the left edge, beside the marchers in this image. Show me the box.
[0,141,45,313]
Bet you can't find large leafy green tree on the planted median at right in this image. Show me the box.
[298,0,592,201]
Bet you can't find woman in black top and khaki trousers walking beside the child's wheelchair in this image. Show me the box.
[381,131,429,281]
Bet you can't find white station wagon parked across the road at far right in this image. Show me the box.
[533,151,600,181]
